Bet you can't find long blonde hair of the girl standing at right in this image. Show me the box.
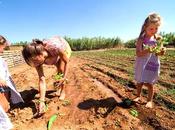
[139,13,161,38]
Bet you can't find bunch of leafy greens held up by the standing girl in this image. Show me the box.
[143,37,168,54]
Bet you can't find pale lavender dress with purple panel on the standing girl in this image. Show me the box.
[135,39,160,84]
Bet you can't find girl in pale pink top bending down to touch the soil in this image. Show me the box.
[22,36,71,113]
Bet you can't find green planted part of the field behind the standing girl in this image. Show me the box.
[73,49,175,97]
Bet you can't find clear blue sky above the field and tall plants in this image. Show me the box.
[0,0,175,42]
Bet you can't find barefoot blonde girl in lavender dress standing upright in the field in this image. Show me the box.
[134,13,165,108]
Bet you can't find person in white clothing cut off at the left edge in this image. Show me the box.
[0,35,24,129]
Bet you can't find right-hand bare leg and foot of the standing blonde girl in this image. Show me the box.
[145,84,154,108]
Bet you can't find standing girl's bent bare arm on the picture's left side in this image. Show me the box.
[136,39,149,57]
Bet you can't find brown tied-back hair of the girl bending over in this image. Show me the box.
[22,39,45,65]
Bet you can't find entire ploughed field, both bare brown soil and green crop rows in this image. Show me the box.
[9,49,175,130]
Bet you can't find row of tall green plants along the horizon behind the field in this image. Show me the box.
[12,32,175,51]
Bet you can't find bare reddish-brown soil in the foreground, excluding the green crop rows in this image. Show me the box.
[8,57,175,130]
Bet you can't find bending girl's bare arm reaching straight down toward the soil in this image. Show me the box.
[36,65,46,101]
